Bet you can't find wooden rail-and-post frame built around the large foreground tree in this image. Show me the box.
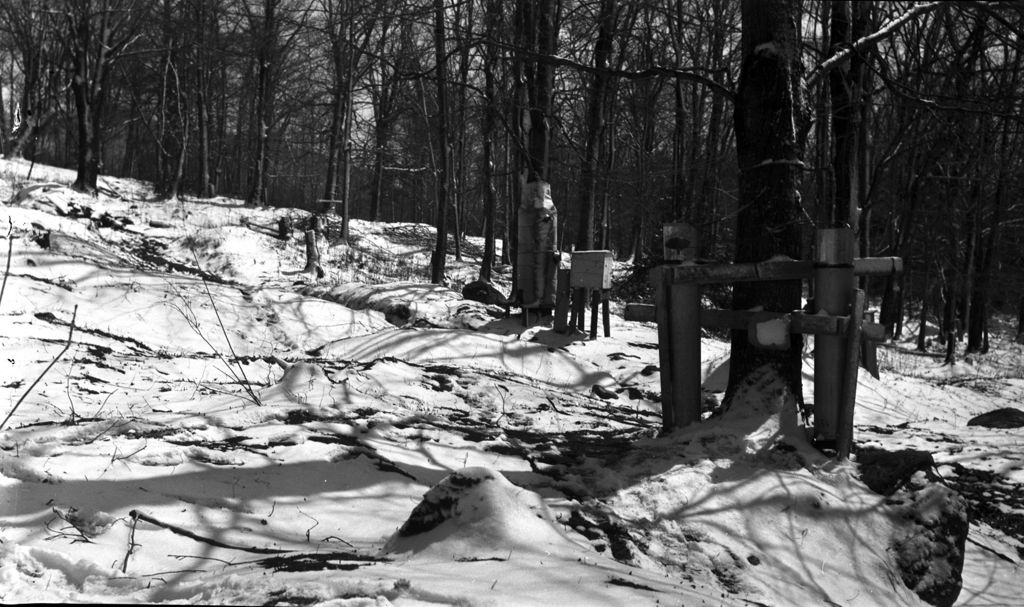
[643,228,903,459]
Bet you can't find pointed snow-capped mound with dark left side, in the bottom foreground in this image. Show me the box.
[383,467,579,560]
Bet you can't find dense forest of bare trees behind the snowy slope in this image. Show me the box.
[0,0,1024,356]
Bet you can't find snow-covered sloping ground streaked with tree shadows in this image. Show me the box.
[0,161,1024,605]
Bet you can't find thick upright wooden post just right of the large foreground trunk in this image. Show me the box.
[814,227,856,444]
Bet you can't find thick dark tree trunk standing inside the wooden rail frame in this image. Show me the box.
[726,0,804,403]
